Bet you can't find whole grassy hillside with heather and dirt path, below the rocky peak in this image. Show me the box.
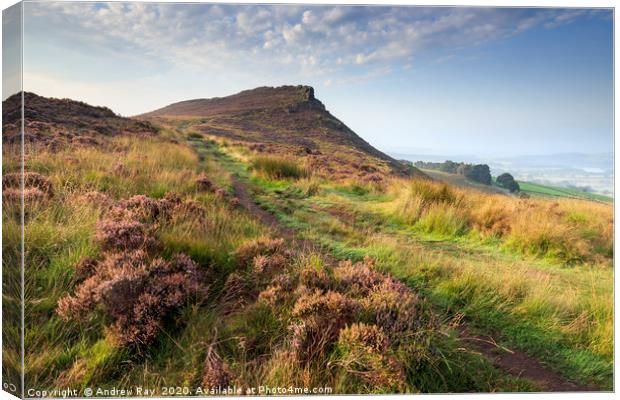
[3,92,613,395]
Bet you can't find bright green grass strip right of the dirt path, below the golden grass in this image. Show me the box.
[234,168,613,389]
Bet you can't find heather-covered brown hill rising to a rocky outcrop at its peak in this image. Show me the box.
[141,86,423,179]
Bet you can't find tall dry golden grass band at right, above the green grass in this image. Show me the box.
[386,179,613,264]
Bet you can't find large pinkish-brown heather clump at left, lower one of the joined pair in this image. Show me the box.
[57,250,206,346]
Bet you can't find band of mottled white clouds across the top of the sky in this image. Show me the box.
[26,2,596,80]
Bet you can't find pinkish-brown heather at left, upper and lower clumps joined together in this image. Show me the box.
[57,195,207,347]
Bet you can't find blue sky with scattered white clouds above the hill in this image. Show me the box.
[3,2,613,156]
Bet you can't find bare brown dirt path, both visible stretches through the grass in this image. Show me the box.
[231,175,599,392]
